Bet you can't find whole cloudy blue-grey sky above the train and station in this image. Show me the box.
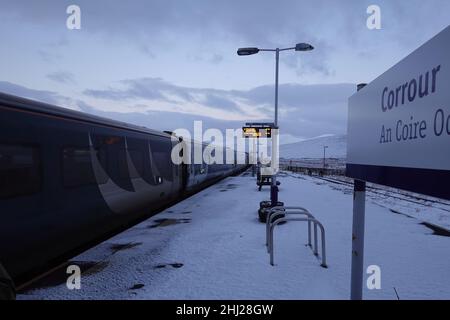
[0,0,450,143]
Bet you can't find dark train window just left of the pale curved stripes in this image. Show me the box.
[62,147,108,188]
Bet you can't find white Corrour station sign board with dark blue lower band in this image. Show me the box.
[347,26,450,199]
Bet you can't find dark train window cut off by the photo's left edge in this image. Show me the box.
[0,144,42,198]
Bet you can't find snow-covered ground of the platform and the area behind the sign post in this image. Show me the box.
[18,173,450,299]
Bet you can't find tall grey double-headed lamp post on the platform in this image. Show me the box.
[237,43,314,206]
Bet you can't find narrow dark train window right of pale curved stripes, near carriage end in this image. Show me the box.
[150,137,174,181]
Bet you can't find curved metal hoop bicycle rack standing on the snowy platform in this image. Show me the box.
[266,207,327,268]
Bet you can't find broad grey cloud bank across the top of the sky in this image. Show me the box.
[0,0,450,81]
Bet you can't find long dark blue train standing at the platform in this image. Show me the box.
[0,93,248,294]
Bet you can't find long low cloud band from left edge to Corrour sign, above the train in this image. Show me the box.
[0,79,355,138]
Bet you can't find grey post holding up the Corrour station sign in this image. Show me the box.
[350,85,366,300]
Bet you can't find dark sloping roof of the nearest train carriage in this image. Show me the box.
[0,92,170,137]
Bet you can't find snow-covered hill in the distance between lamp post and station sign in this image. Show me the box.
[280,135,347,159]
